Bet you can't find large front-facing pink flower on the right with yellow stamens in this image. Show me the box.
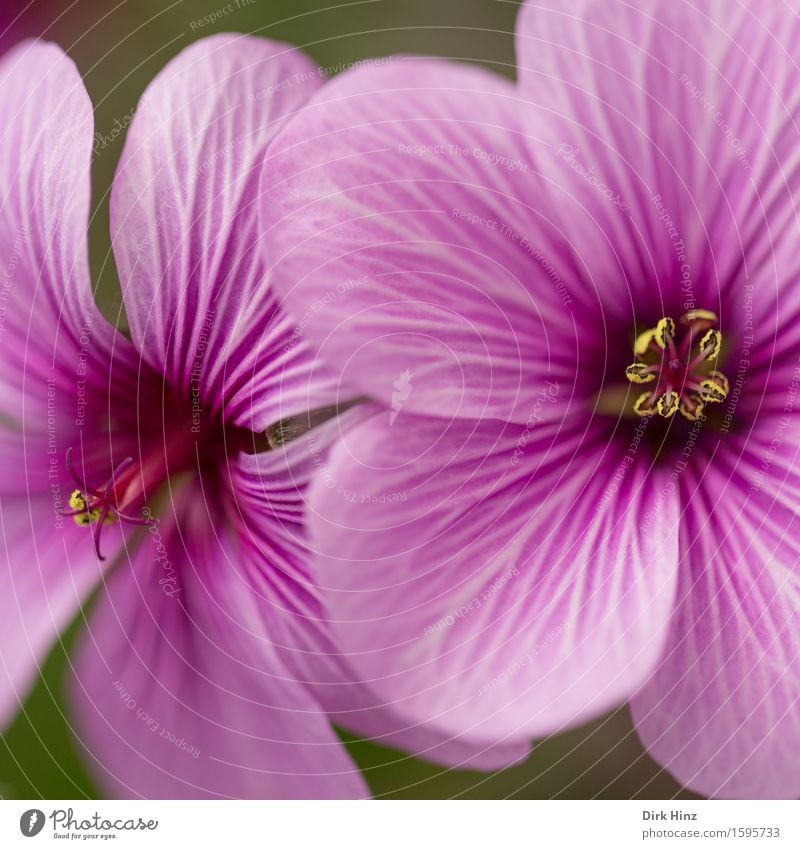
[262,0,800,797]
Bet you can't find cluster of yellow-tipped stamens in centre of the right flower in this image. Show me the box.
[625,310,729,421]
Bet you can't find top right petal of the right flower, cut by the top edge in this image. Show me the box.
[517,0,800,322]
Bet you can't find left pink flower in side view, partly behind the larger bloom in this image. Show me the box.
[0,35,525,798]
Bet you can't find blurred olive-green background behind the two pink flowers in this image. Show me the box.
[0,0,691,799]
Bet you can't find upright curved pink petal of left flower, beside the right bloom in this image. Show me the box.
[111,35,335,430]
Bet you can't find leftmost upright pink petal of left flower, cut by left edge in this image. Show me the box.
[0,41,136,494]
